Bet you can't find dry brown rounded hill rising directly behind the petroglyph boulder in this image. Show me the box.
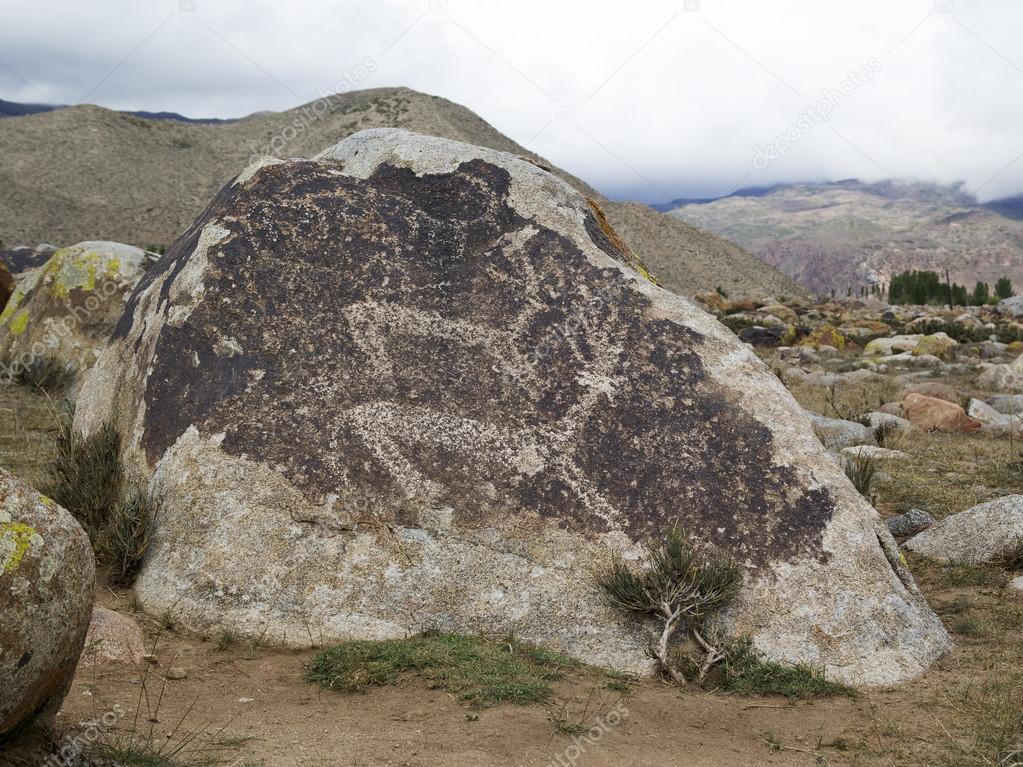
[0,88,800,296]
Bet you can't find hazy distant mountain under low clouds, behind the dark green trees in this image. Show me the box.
[670,179,1023,292]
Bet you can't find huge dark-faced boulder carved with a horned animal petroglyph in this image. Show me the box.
[76,130,948,684]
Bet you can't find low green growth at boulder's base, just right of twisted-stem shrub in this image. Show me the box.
[720,641,856,700]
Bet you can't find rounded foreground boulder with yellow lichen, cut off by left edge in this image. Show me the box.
[0,469,95,741]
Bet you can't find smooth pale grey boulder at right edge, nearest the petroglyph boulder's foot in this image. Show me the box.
[904,495,1023,565]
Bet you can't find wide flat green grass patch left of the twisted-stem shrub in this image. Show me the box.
[306,634,579,708]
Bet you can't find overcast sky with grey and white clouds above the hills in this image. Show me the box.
[0,0,1023,202]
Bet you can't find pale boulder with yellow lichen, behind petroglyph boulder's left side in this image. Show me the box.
[0,241,157,386]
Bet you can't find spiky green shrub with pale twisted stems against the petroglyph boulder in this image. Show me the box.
[599,528,743,684]
